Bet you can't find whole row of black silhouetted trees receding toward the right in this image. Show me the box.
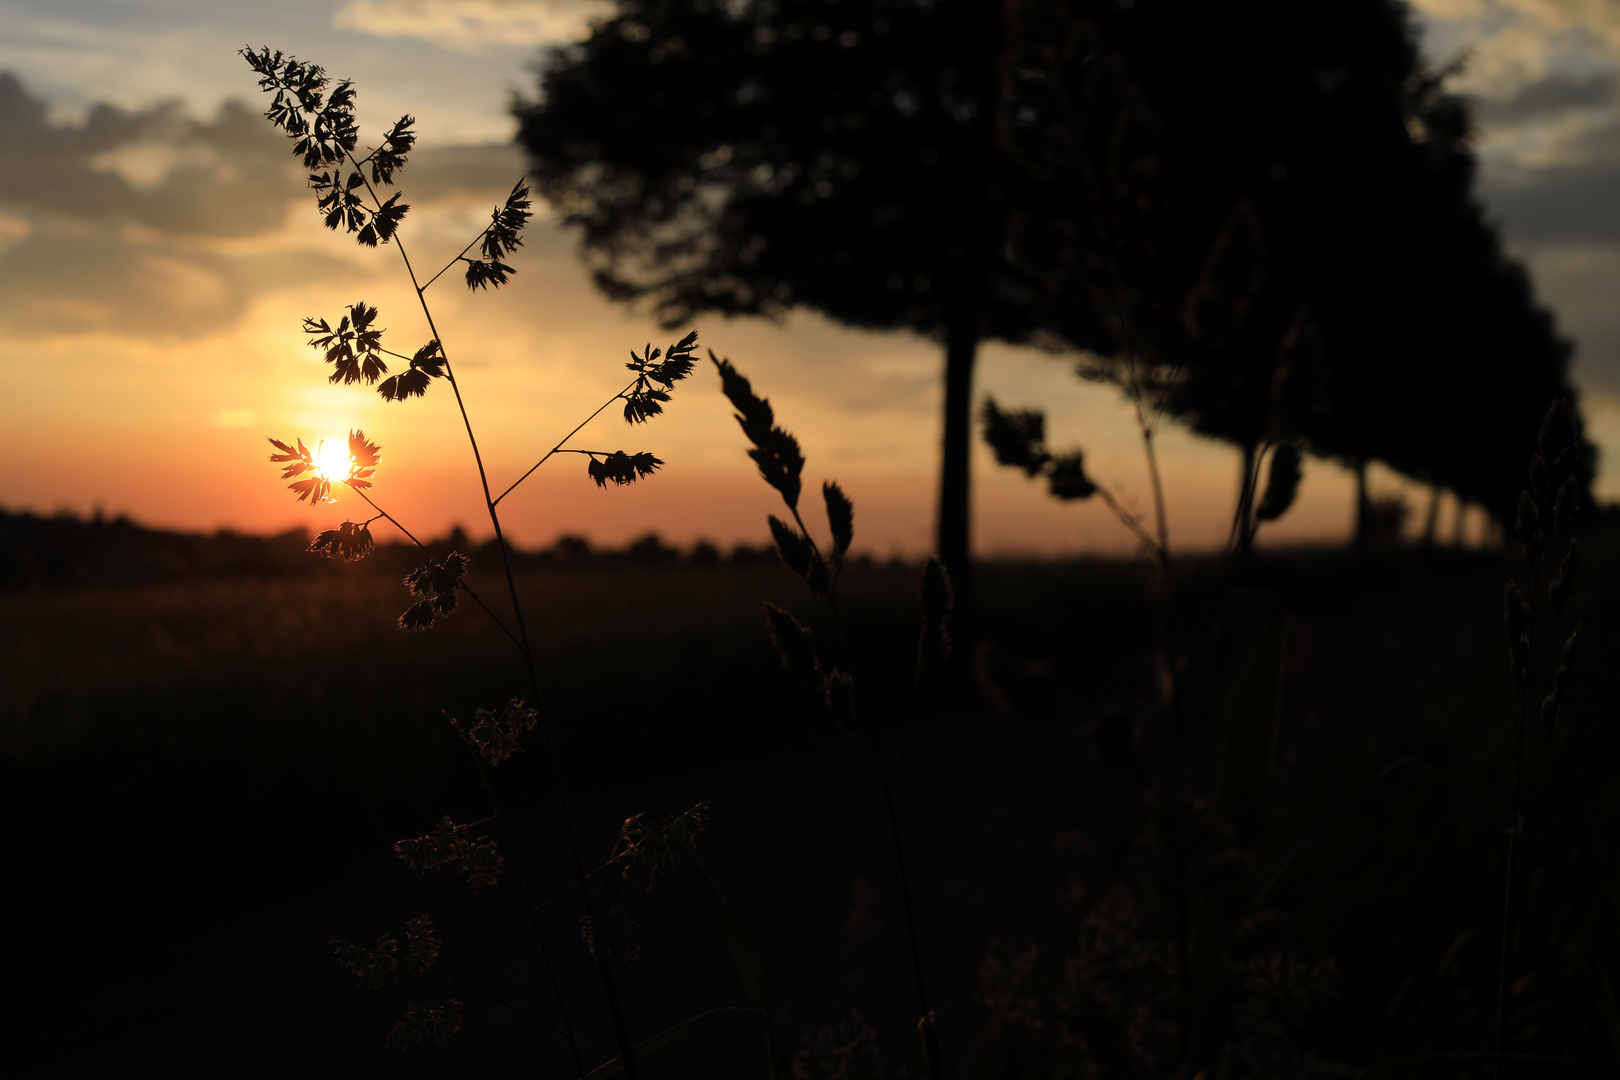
[517,0,1594,586]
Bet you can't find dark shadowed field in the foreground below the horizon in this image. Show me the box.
[0,536,1620,1080]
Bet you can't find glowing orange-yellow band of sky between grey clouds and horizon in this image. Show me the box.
[0,152,1470,554]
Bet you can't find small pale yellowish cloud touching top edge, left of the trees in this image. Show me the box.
[332,0,601,53]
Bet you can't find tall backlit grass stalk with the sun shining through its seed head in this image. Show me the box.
[241,47,709,1080]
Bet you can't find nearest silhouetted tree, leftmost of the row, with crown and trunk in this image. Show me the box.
[517,0,1030,602]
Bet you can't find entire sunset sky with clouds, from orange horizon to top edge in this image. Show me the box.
[0,0,1620,554]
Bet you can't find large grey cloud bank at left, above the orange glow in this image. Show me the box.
[0,73,523,340]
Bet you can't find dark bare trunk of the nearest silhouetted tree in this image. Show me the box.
[938,307,978,634]
